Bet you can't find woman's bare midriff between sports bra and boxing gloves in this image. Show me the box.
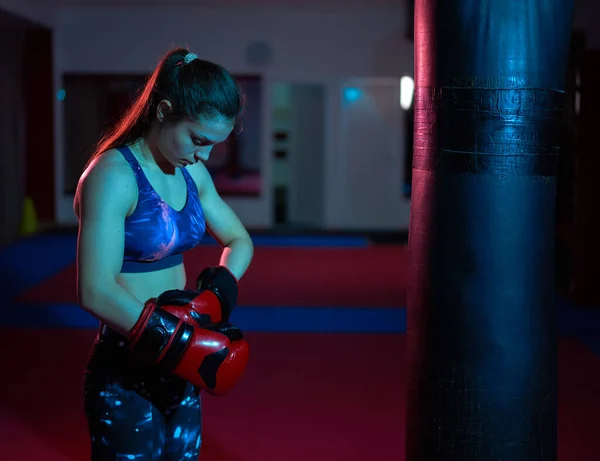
[117,264,186,303]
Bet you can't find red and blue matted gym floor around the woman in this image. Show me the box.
[0,231,600,461]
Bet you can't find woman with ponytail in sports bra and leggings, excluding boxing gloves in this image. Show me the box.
[74,49,253,461]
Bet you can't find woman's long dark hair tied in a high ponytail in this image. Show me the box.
[86,48,244,168]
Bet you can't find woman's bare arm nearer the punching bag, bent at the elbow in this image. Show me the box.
[190,162,254,280]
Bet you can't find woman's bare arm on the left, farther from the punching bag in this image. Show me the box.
[74,152,145,334]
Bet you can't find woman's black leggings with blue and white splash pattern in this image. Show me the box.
[84,327,202,461]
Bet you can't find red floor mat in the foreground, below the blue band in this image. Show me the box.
[0,330,600,461]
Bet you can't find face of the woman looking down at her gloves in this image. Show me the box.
[156,100,234,167]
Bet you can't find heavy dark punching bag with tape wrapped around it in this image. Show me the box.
[406,0,573,461]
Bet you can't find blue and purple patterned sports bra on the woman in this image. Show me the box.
[117,147,206,273]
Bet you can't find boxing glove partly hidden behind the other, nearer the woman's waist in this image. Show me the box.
[156,266,238,325]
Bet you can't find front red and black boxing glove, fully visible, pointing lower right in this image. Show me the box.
[129,301,249,395]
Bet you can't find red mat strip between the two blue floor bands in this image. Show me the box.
[19,246,409,307]
